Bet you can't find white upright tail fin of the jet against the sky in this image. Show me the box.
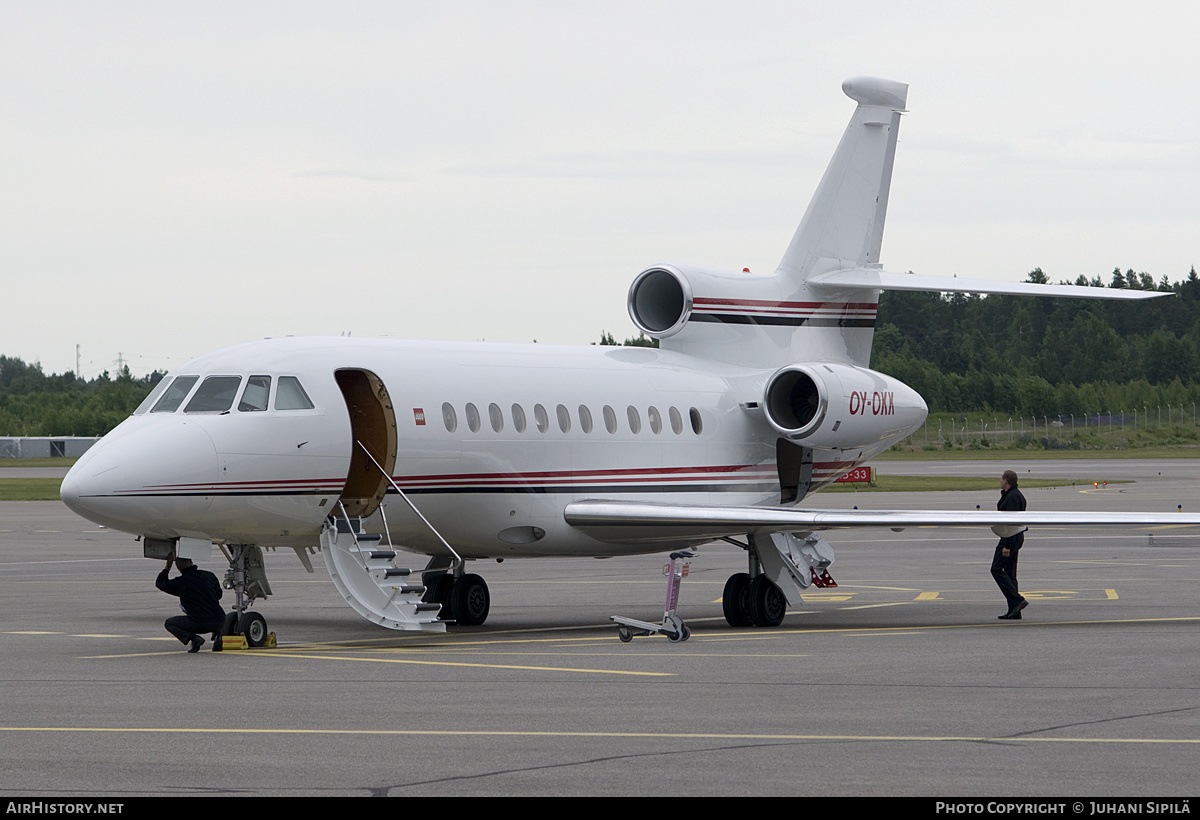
[778,77,908,287]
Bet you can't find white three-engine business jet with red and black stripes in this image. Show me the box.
[61,78,1200,645]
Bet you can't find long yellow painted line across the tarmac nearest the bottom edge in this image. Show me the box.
[0,726,1200,746]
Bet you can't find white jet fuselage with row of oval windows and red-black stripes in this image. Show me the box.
[62,337,924,558]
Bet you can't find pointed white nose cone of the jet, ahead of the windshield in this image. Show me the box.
[59,415,218,537]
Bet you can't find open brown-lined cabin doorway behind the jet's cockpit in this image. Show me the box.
[334,370,396,519]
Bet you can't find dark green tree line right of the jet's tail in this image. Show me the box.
[871,268,1200,415]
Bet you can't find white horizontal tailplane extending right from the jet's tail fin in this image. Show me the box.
[809,268,1171,299]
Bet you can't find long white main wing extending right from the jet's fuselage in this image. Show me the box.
[564,501,1200,543]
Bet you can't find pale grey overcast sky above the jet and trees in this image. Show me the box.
[0,0,1200,377]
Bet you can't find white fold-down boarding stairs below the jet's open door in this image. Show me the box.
[320,503,446,632]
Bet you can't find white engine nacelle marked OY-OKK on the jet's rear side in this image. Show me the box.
[762,363,929,450]
